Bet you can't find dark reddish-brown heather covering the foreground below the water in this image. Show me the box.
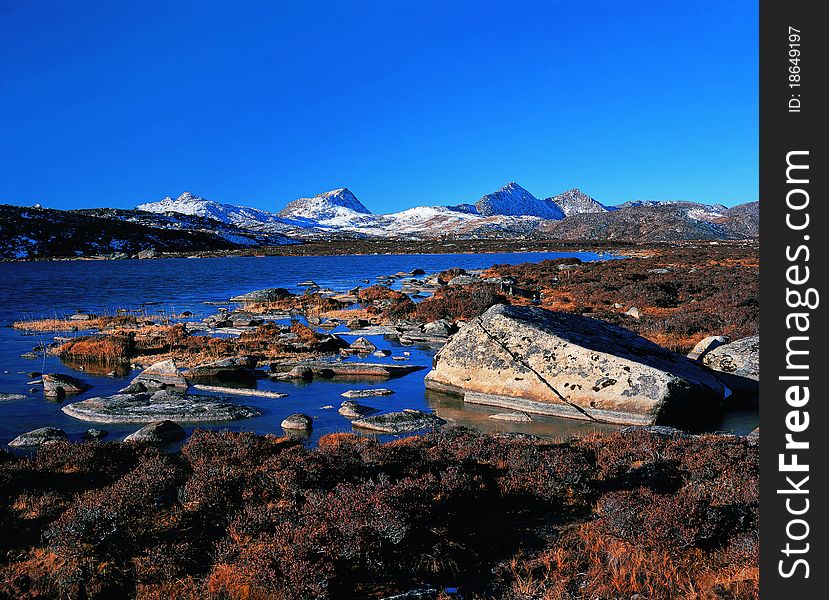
[0,429,758,599]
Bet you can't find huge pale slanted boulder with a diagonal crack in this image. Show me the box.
[426,305,725,424]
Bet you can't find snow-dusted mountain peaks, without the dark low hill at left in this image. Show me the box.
[129,182,756,240]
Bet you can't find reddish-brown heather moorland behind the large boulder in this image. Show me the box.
[478,245,759,352]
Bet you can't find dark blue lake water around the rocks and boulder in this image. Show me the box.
[0,252,756,446]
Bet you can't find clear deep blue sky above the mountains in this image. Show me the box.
[0,0,758,212]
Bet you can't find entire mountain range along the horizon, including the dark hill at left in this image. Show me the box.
[0,182,759,259]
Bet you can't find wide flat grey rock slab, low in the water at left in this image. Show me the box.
[61,390,260,423]
